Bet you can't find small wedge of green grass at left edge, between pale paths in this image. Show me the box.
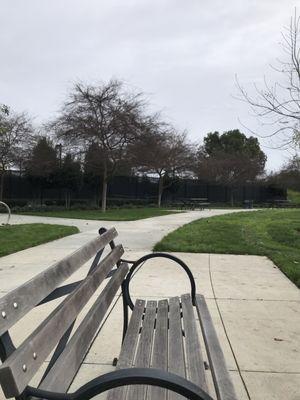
[0,224,79,257]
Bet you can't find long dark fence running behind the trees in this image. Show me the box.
[4,173,287,205]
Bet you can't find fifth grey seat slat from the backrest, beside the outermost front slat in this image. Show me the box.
[181,294,207,391]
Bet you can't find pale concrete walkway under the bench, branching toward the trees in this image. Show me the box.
[0,210,300,400]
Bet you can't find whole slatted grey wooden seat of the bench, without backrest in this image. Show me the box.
[107,294,237,400]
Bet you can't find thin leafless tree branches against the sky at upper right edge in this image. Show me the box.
[237,10,300,147]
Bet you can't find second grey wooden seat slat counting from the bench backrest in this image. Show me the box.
[126,301,157,400]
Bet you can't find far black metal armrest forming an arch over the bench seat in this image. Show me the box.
[124,253,196,310]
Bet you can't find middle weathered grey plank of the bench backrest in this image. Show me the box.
[0,246,124,397]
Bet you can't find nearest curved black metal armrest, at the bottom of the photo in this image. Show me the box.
[26,368,213,400]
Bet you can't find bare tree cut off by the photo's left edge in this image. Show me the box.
[0,107,33,200]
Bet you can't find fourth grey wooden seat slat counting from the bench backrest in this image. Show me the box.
[169,297,186,400]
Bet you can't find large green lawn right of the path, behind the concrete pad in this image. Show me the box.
[154,209,300,287]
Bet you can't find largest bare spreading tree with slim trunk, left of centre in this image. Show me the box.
[53,80,144,212]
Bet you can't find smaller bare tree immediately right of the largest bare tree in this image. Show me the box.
[129,117,192,207]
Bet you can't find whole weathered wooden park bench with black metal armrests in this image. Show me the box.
[0,228,236,400]
